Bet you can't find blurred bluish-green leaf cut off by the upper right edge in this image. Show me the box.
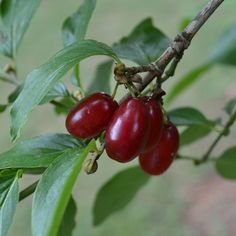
[208,23,236,66]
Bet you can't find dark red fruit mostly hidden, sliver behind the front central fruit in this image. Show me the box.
[143,97,164,153]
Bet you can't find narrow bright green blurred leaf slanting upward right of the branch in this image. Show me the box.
[165,64,211,103]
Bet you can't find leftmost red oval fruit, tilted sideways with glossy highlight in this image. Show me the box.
[66,93,118,138]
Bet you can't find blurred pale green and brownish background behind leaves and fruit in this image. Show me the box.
[0,0,236,236]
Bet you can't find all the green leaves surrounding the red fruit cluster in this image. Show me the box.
[0,0,236,236]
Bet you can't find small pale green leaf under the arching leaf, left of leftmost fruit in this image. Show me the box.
[39,82,70,105]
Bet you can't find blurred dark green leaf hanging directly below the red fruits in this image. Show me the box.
[93,166,150,225]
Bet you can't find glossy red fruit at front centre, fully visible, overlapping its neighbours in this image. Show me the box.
[105,98,149,162]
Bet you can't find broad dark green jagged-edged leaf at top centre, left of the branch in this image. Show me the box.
[113,18,170,65]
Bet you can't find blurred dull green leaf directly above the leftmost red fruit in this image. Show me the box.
[87,61,113,94]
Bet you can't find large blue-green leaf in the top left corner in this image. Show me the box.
[0,0,41,58]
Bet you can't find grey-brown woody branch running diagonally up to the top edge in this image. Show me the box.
[138,0,224,91]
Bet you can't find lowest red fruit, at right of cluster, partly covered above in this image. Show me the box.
[139,122,179,175]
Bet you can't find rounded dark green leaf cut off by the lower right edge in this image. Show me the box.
[215,147,236,179]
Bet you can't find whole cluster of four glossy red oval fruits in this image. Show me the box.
[66,93,179,175]
